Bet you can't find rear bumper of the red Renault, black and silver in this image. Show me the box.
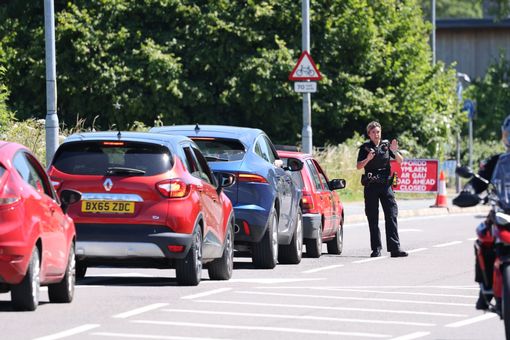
[76,224,192,262]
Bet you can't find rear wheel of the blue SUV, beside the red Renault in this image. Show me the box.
[252,210,278,269]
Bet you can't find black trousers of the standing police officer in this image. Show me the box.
[364,183,400,252]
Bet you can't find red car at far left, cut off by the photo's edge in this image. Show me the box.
[0,141,80,311]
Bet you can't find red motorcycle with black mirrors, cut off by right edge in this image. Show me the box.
[453,153,510,340]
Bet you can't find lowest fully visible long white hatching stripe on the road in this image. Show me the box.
[131,320,390,339]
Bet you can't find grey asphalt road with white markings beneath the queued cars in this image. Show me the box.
[0,213,504,340]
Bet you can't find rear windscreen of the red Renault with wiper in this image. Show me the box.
[53,141,173,176]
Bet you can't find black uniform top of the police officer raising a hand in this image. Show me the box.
[358,139,395,179]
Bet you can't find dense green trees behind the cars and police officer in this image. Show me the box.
[0,0,460,155]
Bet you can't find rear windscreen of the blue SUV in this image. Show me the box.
[191,137,246,162]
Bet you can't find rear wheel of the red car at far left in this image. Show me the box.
[11,247,41,311]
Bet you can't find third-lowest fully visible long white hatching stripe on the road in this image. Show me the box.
[197,300,468,318]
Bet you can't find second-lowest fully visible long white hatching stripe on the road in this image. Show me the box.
[162,308,436,327]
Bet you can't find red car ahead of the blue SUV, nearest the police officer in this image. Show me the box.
[278,150,345,257]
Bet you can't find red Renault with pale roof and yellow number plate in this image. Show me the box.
[49,132,235,285]
